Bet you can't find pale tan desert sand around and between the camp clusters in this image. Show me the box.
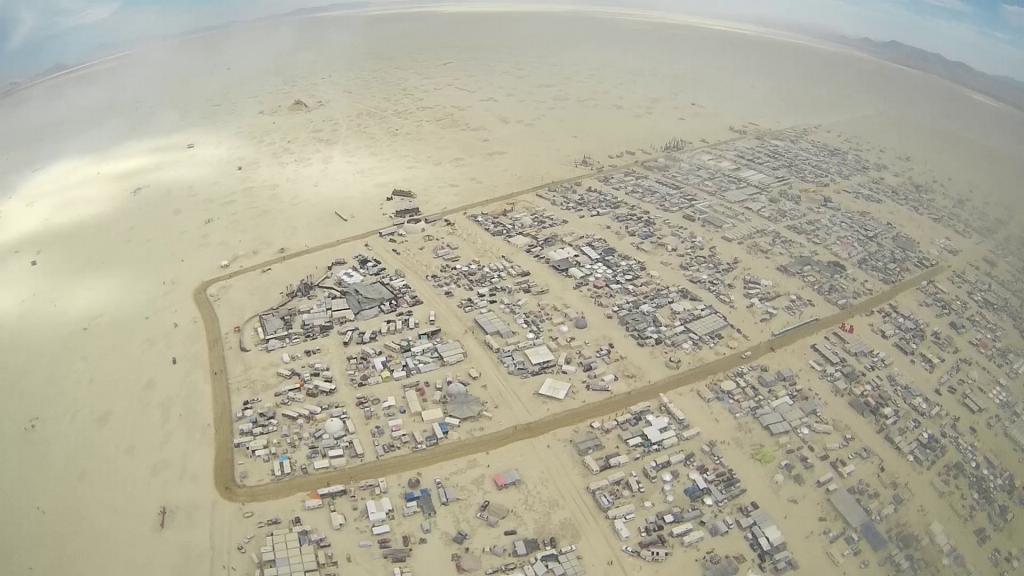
[0,4,1024,574]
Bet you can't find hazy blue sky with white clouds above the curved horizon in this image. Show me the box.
[0,0,1024,80]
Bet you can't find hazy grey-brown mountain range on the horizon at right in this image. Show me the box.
[829,36,1024,112]
